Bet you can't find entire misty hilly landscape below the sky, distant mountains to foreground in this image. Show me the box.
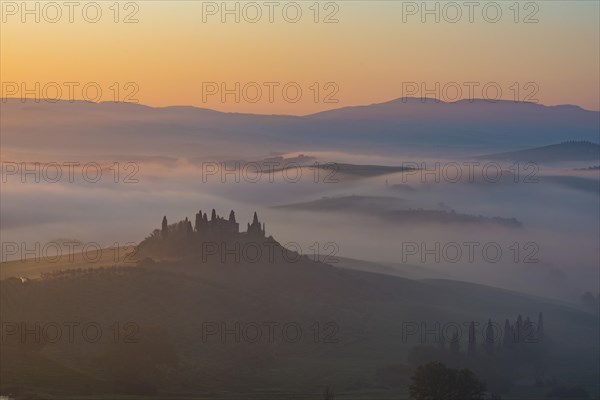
[0,100,600,399]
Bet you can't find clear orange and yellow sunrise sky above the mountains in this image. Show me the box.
[0,0,600,114]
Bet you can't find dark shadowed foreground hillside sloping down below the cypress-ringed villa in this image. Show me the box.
[0,213,598,399]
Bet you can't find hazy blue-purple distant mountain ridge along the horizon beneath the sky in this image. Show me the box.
[0,98,600,157]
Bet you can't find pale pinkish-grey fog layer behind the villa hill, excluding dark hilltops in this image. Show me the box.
[0,153,600,299]
